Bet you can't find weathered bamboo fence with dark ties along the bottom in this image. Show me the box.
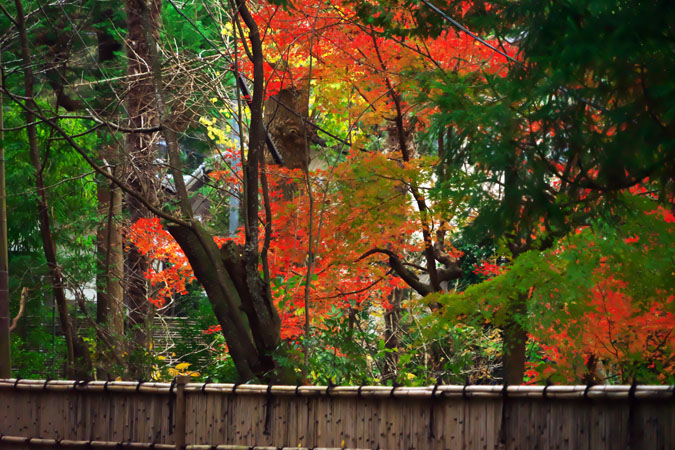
[0,377,675,450]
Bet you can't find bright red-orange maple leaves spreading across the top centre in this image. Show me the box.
[243,1,515,132]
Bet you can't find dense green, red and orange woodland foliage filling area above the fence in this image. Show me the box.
[0,0,675,385]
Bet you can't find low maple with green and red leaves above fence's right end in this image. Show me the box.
[426,194,675,383]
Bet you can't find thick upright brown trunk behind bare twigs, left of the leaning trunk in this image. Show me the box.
[124,0,161,378]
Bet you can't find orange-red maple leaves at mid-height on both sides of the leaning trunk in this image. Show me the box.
[130,153,440,339]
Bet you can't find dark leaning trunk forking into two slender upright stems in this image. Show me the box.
[146,3,288,382]
